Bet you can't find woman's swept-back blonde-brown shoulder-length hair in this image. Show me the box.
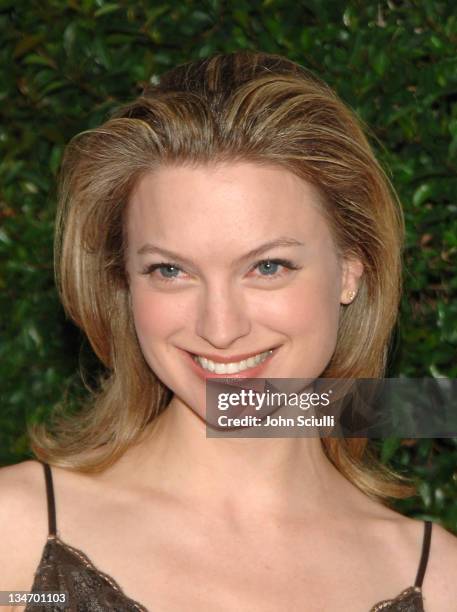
[29,51,414,500]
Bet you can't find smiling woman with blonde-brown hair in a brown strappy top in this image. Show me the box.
[0,52,457,612]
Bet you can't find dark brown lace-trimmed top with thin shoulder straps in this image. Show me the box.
[25,463,432,612]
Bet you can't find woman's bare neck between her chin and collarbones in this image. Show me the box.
[110,397,364,519]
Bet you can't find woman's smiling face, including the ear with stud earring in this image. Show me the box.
[123,162,363,417]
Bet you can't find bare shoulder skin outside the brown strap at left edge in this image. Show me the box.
[0,460,48,590]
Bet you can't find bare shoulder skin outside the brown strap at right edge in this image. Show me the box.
[422,523,457,612]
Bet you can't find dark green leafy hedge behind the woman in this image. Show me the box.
[0,0,457,533]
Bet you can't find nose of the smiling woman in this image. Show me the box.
[192,285,251,349]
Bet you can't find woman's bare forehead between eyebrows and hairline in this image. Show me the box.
[127,162,328,253]
